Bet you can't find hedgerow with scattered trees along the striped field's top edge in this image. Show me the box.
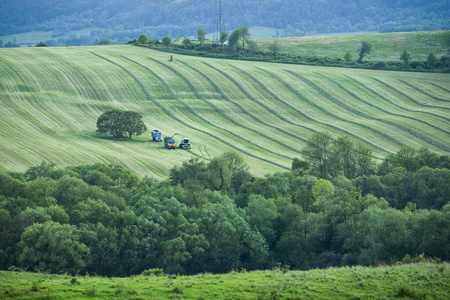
[132,26,450,72]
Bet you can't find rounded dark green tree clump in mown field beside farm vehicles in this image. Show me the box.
[97,109,147,139]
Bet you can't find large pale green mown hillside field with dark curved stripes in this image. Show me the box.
[0,45,450,179]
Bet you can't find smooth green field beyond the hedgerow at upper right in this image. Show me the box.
[255,30,450,61]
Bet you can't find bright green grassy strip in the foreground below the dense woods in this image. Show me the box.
[0,263,450,299]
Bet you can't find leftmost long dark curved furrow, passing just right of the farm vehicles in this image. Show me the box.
[93,53,289,170]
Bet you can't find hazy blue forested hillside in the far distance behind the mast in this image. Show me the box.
[0,0,450,41]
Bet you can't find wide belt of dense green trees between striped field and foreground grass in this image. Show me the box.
[0,133,450,276]
